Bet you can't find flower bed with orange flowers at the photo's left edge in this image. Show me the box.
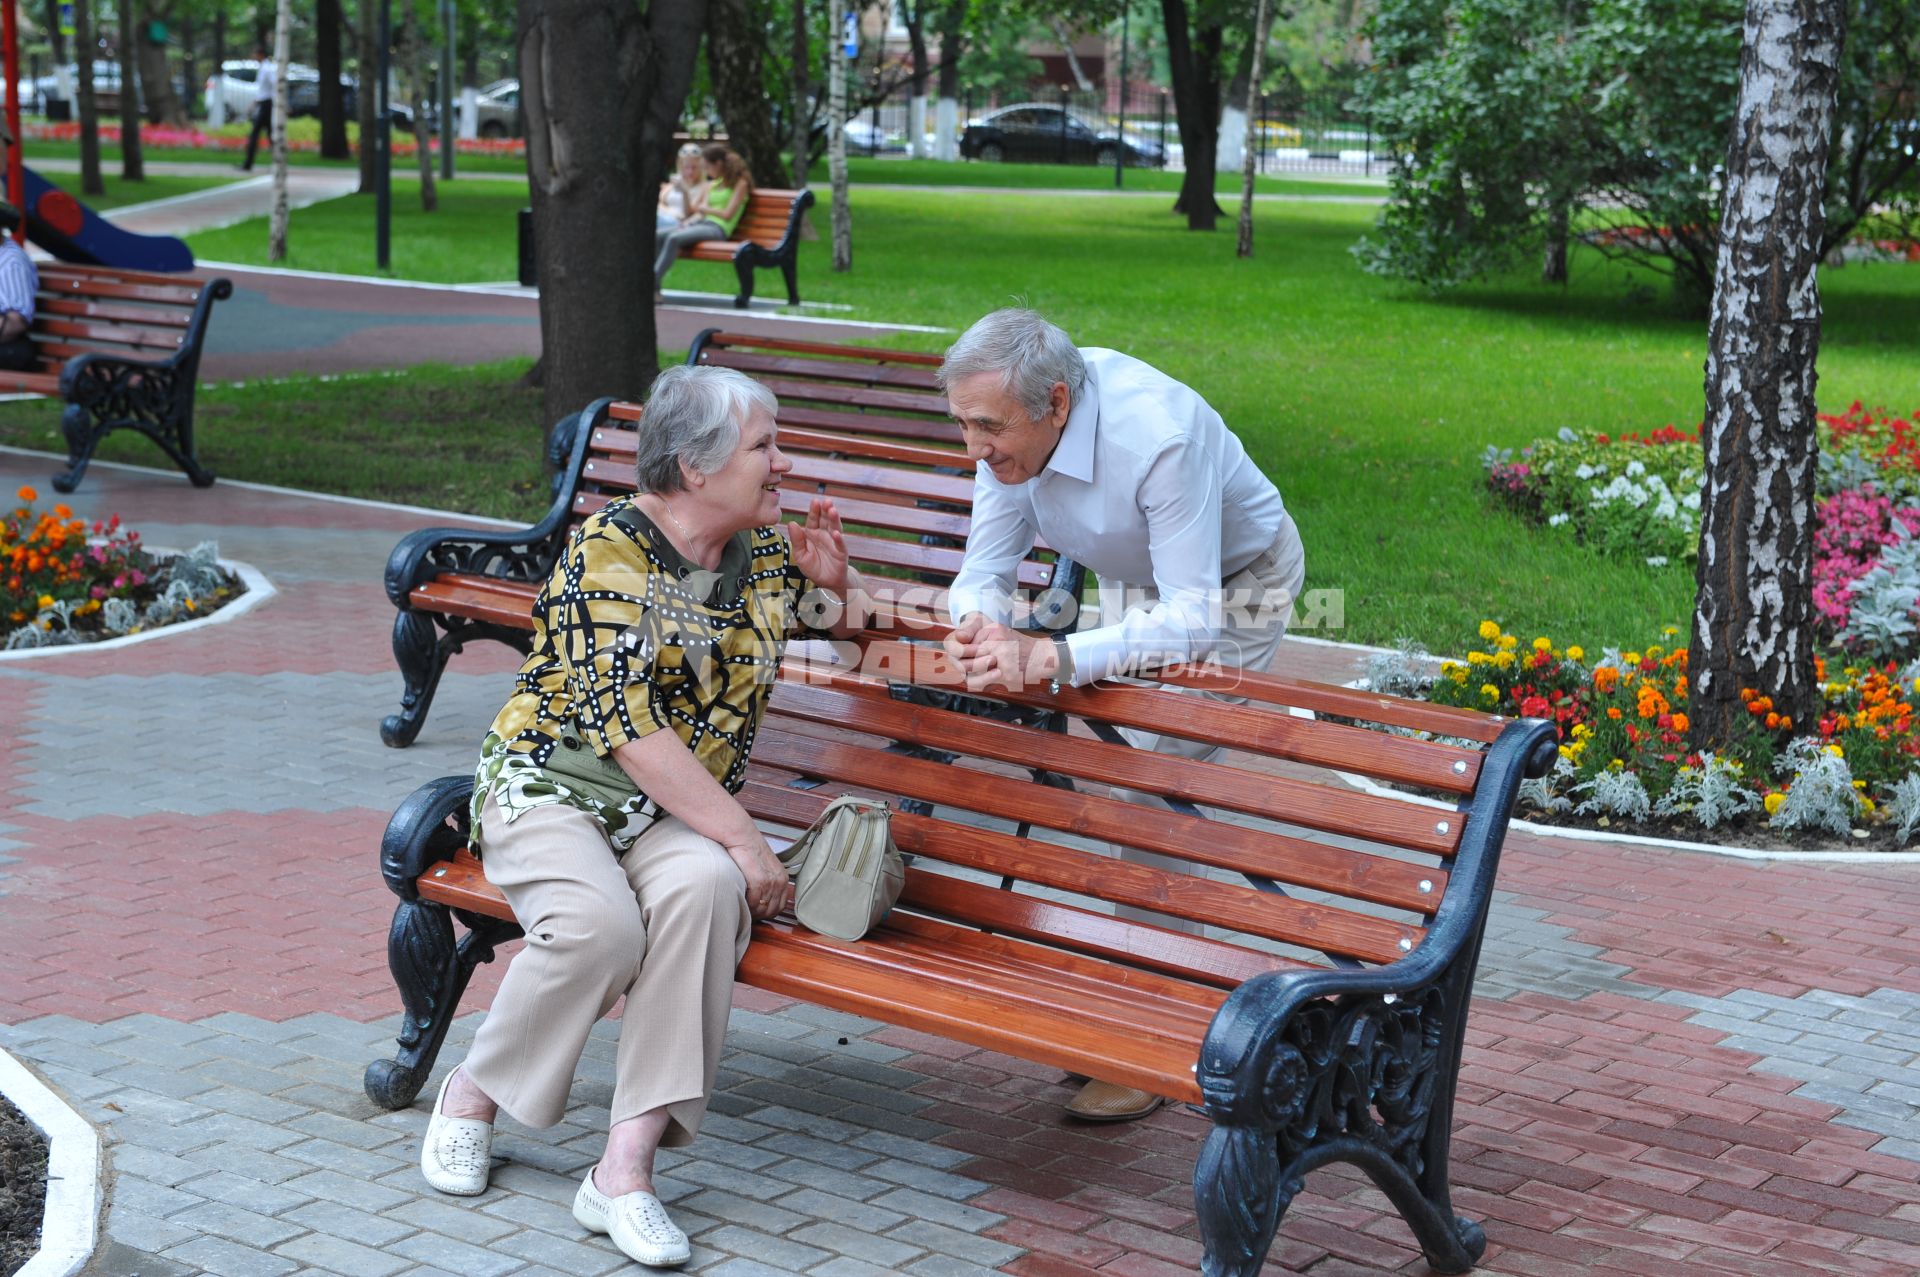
[0,488,244,651]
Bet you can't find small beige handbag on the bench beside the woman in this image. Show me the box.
[780,793,906,941]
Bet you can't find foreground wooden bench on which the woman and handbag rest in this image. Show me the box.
[365,639,1553,1277]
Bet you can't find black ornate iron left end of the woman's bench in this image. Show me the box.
[363,901,520,1108]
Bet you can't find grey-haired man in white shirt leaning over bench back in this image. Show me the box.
[939,309,1306,1121]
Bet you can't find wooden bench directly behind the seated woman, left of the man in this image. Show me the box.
[380,334,1081,749]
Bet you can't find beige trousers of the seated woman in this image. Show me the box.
[467,799,753,1148]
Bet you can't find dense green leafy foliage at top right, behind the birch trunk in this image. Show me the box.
[1356,0,1920,297]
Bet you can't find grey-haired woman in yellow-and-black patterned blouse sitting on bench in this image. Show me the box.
[420,367,866,1265]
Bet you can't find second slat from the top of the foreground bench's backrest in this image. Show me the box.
[833,638,1478,798]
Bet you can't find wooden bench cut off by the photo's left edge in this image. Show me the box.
[0,263,234,492]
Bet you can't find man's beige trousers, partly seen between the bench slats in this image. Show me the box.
[1100,515,1308,935]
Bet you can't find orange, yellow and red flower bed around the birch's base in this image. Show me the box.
[1369,620,1920,851]
